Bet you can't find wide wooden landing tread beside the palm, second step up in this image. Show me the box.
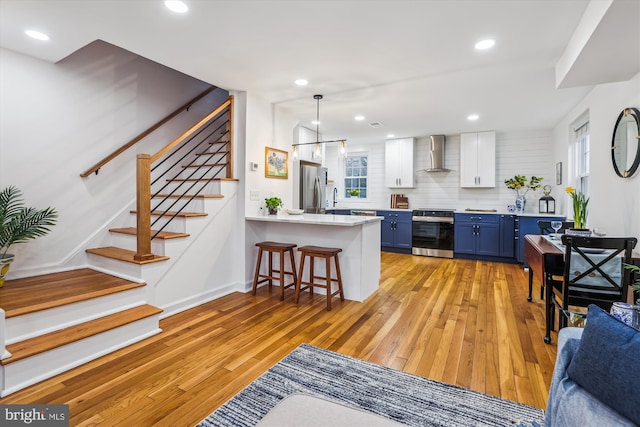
[0,268,145,318]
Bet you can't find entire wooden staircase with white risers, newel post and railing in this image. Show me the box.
[0,95,238,397]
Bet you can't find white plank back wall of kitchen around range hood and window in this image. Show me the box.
[325,130,562,213]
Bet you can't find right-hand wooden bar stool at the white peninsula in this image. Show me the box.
[294,246,344,311]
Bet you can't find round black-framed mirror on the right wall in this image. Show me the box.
[611,108,640,178]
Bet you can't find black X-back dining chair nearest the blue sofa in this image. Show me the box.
[544,234,638,343]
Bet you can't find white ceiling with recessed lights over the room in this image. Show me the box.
[0,0,640,142]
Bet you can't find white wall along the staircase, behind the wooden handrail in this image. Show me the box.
[0,42,226,278]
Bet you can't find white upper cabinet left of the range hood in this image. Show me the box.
[384,138,414,188]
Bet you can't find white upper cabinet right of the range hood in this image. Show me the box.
[460,131,496,188]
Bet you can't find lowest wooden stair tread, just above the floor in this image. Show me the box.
[1,304,162,365]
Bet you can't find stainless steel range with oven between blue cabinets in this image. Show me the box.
[411,209,454,258]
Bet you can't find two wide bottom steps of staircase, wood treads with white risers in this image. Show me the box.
[0,268,162,396]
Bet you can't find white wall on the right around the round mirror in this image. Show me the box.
[553,74,640,241]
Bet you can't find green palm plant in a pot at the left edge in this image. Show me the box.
[0,186,58,288]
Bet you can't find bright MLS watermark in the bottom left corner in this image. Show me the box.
[0,405,69,427]
